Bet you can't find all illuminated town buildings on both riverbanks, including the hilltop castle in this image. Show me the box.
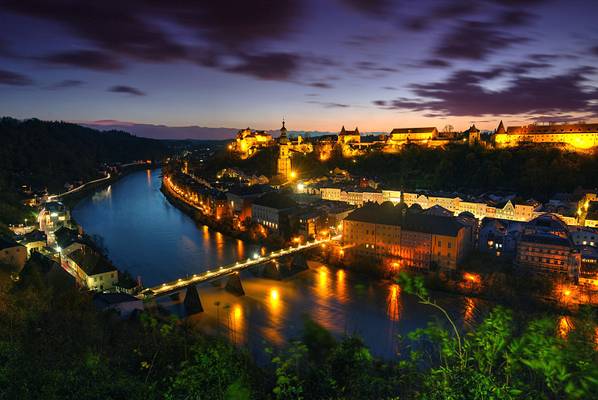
[0,122,598,312]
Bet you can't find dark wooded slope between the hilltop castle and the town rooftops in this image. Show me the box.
[206,144,598,200]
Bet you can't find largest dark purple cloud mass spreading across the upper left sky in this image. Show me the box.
[2,0,303,79]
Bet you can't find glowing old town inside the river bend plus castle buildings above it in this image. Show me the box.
[158,122,598,304]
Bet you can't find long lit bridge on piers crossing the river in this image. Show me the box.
[137,235,341,313]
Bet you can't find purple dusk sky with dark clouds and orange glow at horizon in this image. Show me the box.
[0,0,598,138]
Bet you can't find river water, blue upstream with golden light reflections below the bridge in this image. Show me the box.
[73,170,485,358]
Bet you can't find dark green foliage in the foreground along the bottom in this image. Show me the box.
[0,260,598,400]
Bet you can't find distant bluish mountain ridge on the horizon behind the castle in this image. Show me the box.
[80,120,337,140]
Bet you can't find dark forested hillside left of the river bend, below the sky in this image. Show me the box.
[0,118,166,191]
